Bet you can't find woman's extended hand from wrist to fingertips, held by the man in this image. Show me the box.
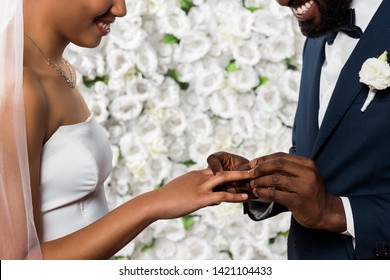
[152,169,249,219]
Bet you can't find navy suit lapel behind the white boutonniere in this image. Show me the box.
[311,0,390,158]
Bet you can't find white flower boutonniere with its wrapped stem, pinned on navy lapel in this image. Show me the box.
[359,51,390,112]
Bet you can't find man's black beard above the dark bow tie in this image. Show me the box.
[299,0,352,38]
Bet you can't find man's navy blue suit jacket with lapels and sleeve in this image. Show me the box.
[246,0,390,259]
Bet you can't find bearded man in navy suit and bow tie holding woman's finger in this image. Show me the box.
[208,0,390,259]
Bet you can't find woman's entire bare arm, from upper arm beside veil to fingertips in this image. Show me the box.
[24,70,249,259]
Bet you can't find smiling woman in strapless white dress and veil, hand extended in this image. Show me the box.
[0,0,249,259]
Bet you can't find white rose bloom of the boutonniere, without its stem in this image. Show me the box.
[359,58,390,90]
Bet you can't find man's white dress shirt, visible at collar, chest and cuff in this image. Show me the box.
[318,0,382,237]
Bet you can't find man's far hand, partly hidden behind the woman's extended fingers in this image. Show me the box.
[207,152,254,197]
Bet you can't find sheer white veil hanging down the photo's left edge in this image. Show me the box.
[0,0,42,260]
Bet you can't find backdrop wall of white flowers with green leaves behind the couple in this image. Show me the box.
[67,0,303,260]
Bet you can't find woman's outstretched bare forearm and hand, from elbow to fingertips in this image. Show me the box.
[41,170,248,259]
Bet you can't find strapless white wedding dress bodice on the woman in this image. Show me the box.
[41,115,112,241]
